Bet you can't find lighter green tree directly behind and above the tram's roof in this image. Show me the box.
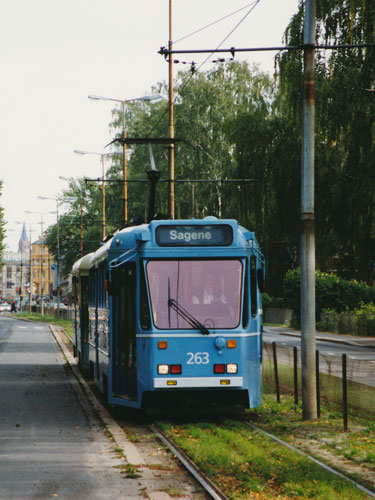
[108,62,273,223]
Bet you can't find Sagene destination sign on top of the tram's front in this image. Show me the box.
[156,224,233,247]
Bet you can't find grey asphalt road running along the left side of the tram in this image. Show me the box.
[0,316,141,500]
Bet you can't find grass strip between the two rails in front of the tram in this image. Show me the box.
[159,412,374,500]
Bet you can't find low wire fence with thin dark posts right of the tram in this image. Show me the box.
[263,342,375,428]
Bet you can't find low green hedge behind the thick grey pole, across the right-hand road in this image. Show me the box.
[283,269,375,324]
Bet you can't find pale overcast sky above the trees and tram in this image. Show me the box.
[0,0,299,251]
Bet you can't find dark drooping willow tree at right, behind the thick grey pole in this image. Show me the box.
[279,0,375,280]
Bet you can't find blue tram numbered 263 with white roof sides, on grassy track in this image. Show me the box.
[73,217,264,408]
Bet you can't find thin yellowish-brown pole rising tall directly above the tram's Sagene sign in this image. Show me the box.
[168,0,175,219]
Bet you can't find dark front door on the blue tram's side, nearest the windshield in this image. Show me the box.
[112,262,137,399]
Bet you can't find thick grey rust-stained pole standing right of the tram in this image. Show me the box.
[301,0,317,420]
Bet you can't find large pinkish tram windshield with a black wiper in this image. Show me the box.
[146,259,243,333]
